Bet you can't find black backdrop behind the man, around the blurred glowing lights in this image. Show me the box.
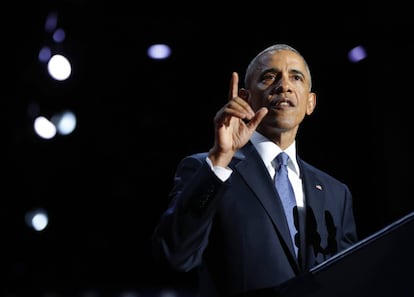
[6,1,414,296]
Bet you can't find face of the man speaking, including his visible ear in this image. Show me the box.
[248,50,316,132]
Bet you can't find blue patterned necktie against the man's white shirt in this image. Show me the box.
[275,152,298,255]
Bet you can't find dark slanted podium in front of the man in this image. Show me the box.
[275,212,414,297]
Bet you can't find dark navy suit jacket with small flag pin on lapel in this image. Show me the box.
[153,142,357,297]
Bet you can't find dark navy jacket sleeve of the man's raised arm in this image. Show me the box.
[152,154,226,271]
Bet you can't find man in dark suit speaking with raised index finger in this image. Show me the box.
[153,44,357,297]
